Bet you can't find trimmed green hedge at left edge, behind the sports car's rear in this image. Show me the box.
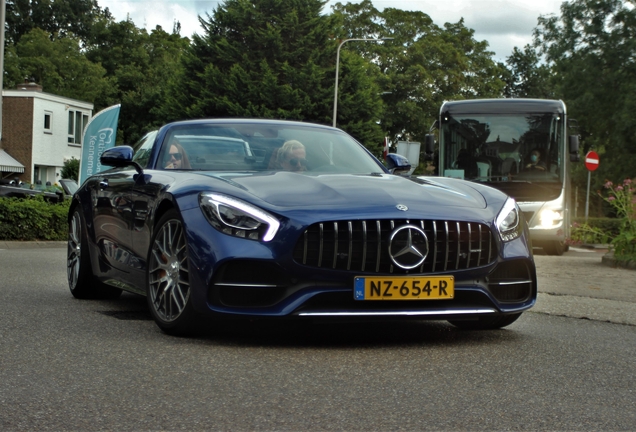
[0,195,70,241]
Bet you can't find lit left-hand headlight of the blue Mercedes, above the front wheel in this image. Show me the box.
[199,193,280,241]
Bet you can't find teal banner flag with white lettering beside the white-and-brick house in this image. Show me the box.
[78,105,121,185]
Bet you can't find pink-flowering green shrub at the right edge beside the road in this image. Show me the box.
[599,179,636,259]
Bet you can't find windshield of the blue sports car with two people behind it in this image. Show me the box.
[157,122,383,174]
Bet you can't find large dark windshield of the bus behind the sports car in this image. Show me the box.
[440,113,565,183]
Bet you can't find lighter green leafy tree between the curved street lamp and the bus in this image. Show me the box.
[333,0,505,141]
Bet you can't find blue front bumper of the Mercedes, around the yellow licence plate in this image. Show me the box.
[183,204,537,319]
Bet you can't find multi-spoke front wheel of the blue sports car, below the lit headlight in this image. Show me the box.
[146,210,198,336]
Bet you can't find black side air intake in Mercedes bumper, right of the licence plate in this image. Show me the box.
[488,261,533,303]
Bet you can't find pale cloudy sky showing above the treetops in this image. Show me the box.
[97,0,561,62]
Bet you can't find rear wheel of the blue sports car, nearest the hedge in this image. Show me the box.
[66,207,121,299]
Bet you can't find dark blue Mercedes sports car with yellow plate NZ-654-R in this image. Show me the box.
[67,119,537,334]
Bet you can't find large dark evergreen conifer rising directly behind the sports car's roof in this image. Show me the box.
[162,0,383,145]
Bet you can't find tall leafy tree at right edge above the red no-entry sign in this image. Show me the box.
[534,0,636,189]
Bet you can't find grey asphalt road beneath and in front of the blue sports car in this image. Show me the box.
[0,244,636,431]
